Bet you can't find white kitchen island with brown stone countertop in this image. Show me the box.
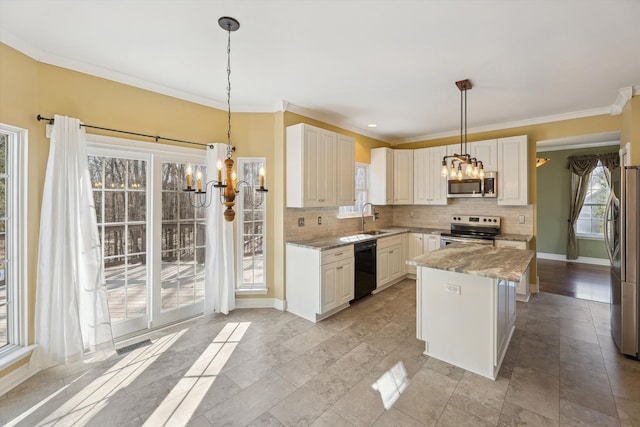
[407,244,534,379]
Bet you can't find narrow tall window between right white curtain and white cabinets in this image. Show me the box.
[236,157,267,294]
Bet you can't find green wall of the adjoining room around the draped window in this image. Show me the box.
[536,145,618,259]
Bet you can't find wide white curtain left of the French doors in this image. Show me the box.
[31,115,112,369]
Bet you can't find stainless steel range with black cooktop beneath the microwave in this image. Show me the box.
[440,215,500,248]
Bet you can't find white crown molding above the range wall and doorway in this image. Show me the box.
[391,107,611,145]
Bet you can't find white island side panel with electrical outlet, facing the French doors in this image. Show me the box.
[417,267,497,379]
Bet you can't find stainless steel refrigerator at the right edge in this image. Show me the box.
[605,160,640,357]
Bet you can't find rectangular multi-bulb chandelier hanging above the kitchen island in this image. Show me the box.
[442,79,484,179]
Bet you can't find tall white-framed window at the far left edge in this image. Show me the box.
[0,124,30,370]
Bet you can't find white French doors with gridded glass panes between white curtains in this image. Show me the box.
[89,143,206,338]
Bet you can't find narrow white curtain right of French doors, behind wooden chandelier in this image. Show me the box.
[204,143,239,314]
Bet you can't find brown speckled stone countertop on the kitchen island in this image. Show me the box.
[407,244,535,282]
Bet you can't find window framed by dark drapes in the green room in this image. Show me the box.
[576,162,609,239]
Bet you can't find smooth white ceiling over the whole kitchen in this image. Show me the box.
[0,0,640,142]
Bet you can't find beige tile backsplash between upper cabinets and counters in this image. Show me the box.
[284,199,534,241]
